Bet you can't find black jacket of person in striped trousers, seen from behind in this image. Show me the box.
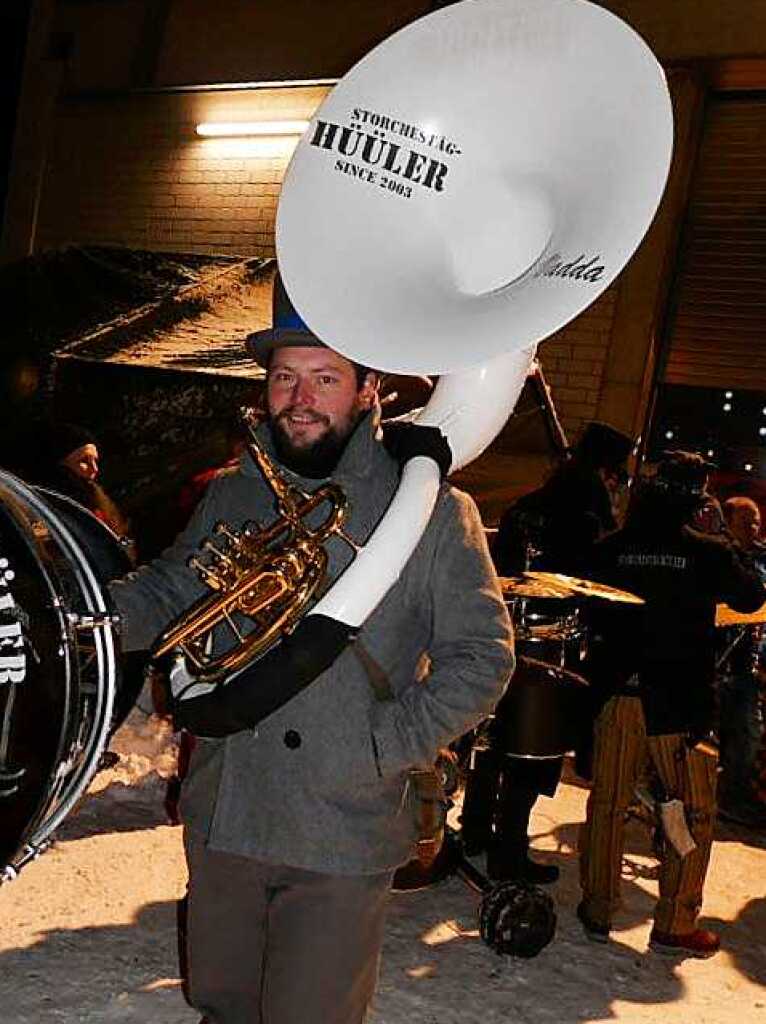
[585,524,766,735]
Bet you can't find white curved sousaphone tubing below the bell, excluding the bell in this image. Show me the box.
[309,346,535,628]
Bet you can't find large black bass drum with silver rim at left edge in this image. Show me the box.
[0,470,130,881]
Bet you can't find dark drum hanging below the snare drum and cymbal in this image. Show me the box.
[488,656,588,761]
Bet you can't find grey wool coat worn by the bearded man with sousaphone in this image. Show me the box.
[111,417,513,874]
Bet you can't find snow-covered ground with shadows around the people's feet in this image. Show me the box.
[0,713,766,1024]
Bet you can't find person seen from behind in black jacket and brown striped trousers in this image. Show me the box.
[578,452,766,956]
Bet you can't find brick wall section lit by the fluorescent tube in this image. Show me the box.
[36,87,327,256]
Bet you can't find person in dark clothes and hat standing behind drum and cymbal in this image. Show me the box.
[461,422,633,884]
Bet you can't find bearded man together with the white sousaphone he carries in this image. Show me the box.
[114,0,672,1007]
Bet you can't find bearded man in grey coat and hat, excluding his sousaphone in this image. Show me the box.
[113,280,513,1024]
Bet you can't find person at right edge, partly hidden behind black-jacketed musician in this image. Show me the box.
[718,497,766,827]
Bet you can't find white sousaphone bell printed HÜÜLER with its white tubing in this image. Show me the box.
[276,0,673,627]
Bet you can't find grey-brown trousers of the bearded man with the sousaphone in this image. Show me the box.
[184,829,391,1024]
